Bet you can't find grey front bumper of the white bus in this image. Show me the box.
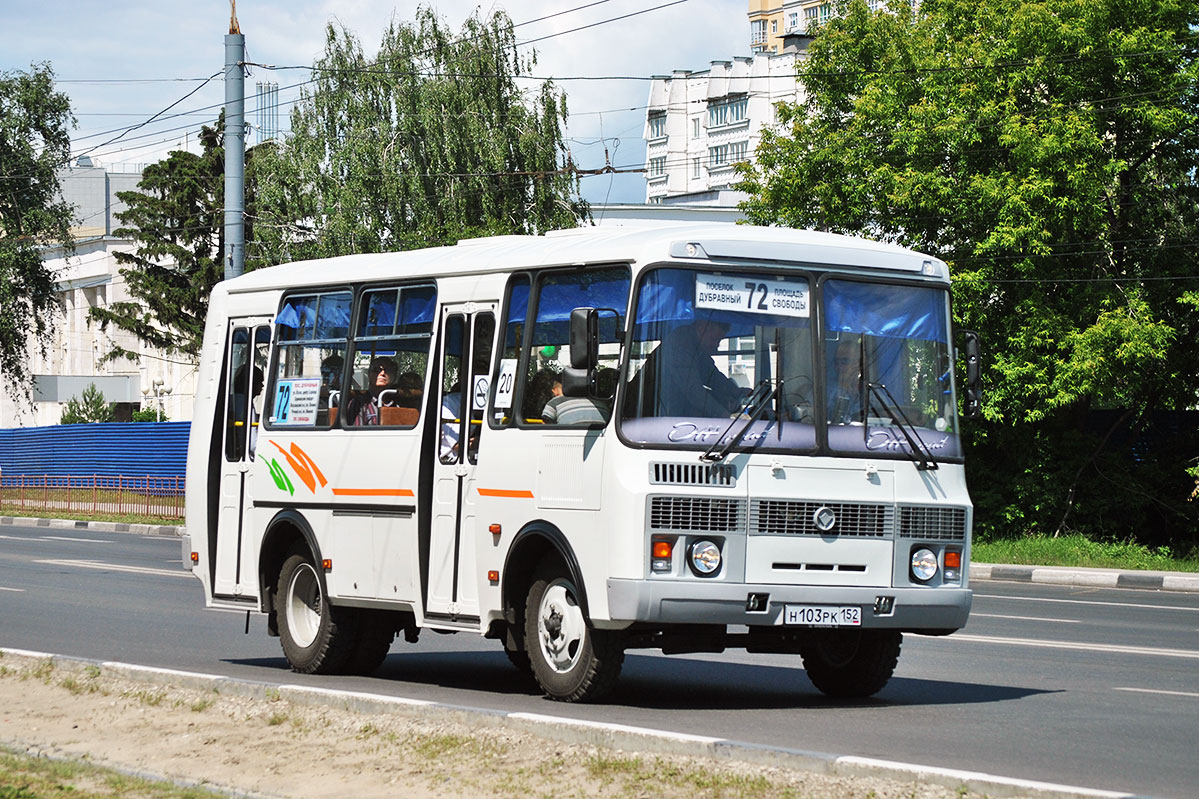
[608,579,974,632]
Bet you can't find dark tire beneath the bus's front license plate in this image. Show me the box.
[800,630,903,699]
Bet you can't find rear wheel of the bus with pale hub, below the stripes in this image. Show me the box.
[276,549,357,674]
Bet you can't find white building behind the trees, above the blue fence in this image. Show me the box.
[0,160,195,427]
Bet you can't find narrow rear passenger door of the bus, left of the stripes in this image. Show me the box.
[212,318,271,599]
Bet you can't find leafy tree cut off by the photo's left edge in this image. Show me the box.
[0,64,74,394]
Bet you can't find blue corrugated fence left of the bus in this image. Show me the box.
[0,422,192,479]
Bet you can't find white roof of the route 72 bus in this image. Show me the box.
[221,223,948,294]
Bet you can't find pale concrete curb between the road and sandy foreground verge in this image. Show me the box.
[0,648,1147,799]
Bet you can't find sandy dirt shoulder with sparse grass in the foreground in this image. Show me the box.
[0,654,1037,799]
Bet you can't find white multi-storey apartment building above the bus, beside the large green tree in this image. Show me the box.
[645,37,807,206]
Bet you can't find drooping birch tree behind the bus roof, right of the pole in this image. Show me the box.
[247,8,586,264]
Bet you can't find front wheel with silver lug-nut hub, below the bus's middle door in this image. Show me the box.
[525,556,625,702]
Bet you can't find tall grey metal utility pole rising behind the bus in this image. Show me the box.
[224,0,246,280]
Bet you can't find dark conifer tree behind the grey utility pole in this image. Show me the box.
[88,113,257,361]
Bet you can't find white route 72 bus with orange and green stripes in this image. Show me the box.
[185,224,977,701]
